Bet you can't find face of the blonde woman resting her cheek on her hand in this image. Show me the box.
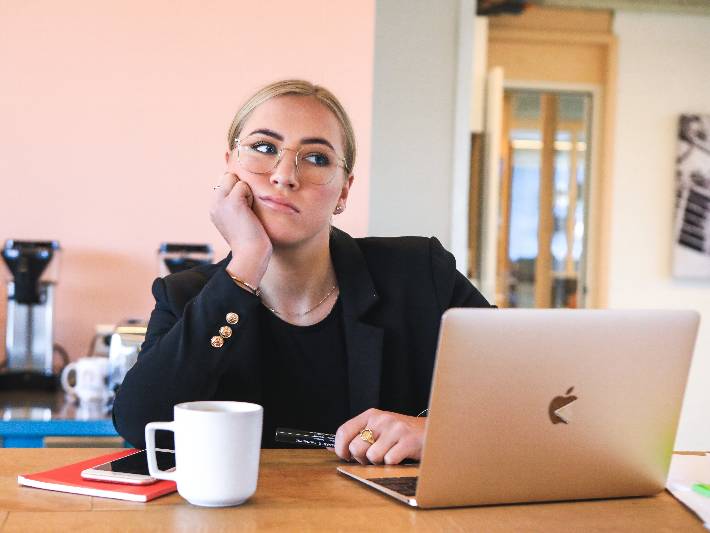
[227,95,353,247]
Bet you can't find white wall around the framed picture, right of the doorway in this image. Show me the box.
[609,12,710,450]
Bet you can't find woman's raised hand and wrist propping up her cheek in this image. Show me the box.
[210,172,273,287]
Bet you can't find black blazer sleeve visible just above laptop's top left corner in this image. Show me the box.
[429,237,495,313]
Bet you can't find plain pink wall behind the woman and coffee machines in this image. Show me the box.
[0,0,374,358]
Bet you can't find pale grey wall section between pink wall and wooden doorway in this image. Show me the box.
[368,0,474,246]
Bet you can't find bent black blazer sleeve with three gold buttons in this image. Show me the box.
[113,269,260,448]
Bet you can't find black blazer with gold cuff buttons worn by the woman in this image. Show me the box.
[113,228,489,448]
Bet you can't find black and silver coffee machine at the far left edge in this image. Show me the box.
[0,239,60,389]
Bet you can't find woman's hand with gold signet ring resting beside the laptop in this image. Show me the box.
[335,409,426,465]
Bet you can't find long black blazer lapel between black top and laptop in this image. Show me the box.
[330,228,384,416]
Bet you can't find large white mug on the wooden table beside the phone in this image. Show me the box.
[145,402,264,507]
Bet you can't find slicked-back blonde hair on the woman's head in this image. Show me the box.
[227,80,355,174]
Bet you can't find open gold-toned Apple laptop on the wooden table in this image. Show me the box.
[338,309,699,508]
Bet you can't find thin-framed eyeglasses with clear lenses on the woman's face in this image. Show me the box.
[235,135,347,185]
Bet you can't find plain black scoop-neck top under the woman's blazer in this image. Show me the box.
[261,299,349,448]
